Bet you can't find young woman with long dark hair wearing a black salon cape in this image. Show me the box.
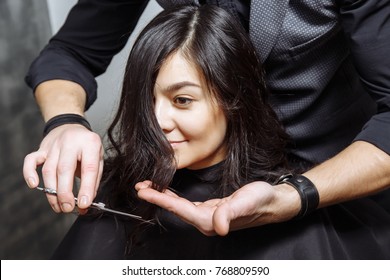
[53,5,390,259]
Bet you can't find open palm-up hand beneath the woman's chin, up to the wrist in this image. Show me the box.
[135,181,300,236]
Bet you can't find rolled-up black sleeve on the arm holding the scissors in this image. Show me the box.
[25,0,148,109]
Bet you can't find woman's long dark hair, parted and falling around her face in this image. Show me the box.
[100,5,286,217]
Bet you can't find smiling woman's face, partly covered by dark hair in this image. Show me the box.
[154,52,227,169]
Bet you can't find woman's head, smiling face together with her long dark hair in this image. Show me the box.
[106,5,287,200]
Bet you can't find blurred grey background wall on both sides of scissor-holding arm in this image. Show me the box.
[0,0,161,260]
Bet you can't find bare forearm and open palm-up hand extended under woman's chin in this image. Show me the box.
[136,141,390,235]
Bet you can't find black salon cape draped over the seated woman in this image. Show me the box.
[53,166,390,260]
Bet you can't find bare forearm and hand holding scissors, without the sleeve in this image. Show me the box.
[23,80,103,212]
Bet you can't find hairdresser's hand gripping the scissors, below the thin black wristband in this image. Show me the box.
[23,124,103,213]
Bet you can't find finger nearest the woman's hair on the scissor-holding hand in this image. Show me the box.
[78,134,103,209]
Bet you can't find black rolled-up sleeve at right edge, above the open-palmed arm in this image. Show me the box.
[341,0,390,154]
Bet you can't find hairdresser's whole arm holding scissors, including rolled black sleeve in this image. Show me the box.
[23,0,148,212]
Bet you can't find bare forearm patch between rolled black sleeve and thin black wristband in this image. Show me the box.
[35,80,86,121]
